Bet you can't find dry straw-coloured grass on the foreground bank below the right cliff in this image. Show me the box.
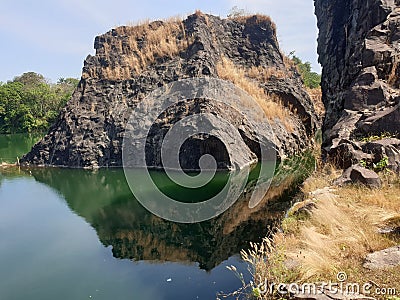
[242,167,400,299]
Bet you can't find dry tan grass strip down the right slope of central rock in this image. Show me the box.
[217,57,293,131]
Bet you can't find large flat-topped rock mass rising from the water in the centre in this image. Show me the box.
[21,13,318,169]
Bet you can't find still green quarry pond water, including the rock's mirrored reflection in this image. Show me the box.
[0,135,314,300]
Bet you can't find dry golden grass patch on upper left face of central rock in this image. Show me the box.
[83,18,192,80]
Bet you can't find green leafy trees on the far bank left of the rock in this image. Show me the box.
[0,72,79,133]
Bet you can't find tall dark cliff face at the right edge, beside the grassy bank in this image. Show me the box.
[315,0,400,172]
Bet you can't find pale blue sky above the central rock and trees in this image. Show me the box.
[0,0,320,82]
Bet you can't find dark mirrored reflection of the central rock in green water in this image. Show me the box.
[22,154,316,270]
